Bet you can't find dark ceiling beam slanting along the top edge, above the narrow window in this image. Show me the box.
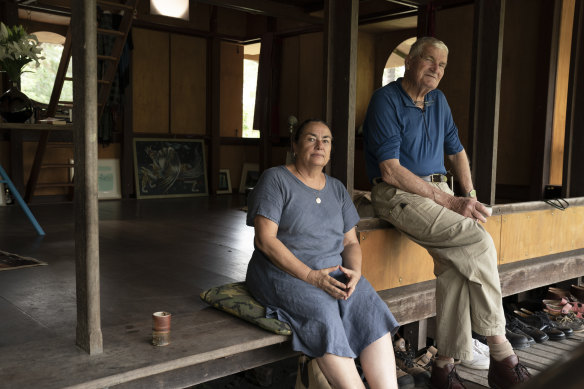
[198,0,323,24]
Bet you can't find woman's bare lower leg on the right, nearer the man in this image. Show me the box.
[360,333,397,389]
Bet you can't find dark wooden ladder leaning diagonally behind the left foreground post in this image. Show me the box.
[24,0,138,203]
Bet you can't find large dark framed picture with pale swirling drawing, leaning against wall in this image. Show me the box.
[134,138,209,199]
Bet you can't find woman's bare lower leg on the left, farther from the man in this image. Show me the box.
[316,354,365,389]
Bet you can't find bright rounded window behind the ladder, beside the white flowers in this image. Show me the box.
[20,31,73,104]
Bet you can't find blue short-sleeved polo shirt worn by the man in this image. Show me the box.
[363,78,463,180]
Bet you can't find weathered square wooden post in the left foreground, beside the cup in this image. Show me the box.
[71,0,103,354]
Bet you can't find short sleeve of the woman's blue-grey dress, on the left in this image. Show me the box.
[246,168,284,227]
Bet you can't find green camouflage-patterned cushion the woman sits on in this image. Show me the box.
[201,282,292,335]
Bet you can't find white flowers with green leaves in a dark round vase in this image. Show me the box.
[0,22,44,123]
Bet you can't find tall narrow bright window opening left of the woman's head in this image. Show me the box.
[241,43,261,138]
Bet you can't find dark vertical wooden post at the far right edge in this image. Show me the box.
[562,1,584,197]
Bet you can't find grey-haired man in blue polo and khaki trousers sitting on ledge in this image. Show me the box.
[364,37,530,389]
